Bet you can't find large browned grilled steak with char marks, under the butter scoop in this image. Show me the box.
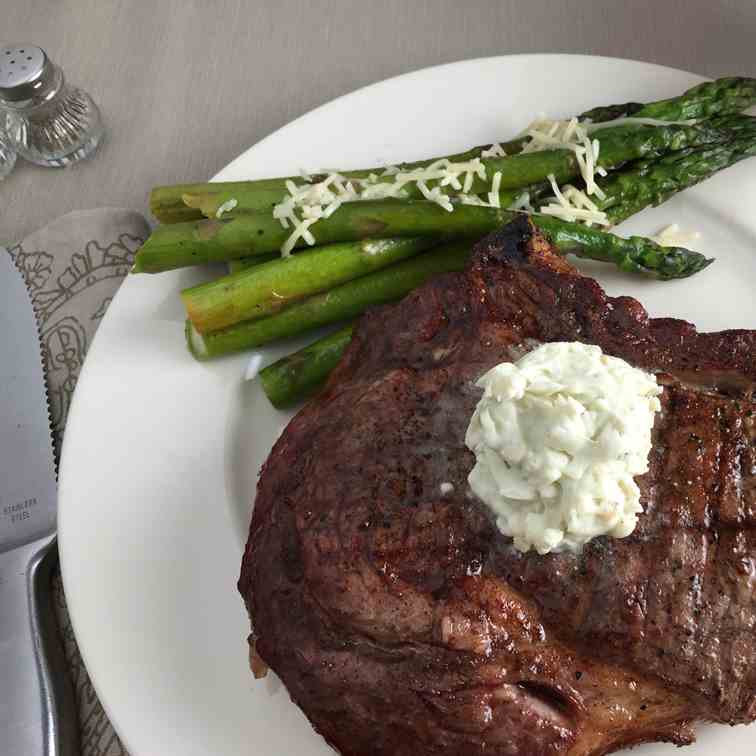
[239,220,756,756]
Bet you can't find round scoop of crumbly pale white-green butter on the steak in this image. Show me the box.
[465,342,661,554]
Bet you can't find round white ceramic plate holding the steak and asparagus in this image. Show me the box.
[60,55,756,756]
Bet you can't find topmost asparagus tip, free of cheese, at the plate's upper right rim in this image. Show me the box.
[580,76,756,123]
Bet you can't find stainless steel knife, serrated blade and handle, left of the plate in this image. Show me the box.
[0,247,78,756]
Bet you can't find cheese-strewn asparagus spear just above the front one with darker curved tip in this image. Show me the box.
[149,118,727,229]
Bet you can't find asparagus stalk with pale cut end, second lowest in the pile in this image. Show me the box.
[186,242,470,360]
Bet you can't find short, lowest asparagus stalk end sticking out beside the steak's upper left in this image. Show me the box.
[260,323,354,409]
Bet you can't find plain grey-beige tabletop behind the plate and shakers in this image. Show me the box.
[0,0,756,242]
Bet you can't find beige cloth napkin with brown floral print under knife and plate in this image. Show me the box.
[8,208,149,756]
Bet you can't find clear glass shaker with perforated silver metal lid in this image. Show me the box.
[0,45,104,167]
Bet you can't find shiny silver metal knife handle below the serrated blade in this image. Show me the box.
[0,537,79,756]
